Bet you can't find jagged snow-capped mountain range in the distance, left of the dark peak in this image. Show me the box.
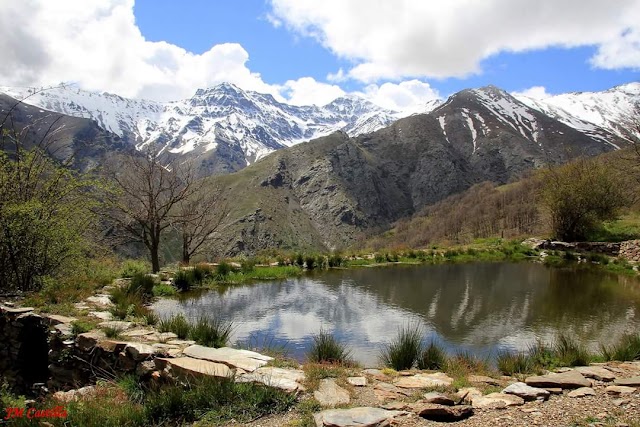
[0,83,420,172]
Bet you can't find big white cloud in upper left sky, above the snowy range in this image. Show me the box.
[0,0,282,100]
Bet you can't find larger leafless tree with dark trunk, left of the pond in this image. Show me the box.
[104,148,197,272]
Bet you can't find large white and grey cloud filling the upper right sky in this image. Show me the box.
[271,0,640,82]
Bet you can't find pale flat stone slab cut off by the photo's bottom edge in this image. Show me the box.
[313,407,405,427]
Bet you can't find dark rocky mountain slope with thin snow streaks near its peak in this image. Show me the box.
[208,86,628,254]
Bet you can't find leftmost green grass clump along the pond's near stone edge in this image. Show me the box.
[158,314,233,348]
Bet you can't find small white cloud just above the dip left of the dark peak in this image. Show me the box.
[363,80,440,111]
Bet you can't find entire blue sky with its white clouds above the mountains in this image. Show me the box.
[0,0,640,109]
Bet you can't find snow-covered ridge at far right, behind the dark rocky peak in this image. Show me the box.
[516,82,640,140]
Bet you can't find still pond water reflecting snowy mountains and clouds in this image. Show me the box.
[155,262,640,366]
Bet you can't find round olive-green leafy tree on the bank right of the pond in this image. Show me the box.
[541,158,631,241]
